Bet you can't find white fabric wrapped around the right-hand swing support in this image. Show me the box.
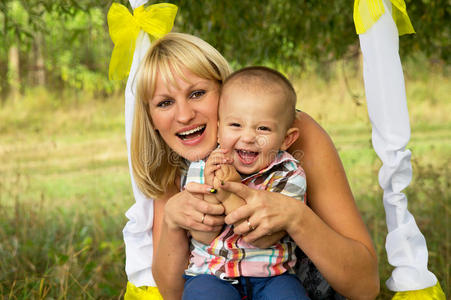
[359,0,437,291]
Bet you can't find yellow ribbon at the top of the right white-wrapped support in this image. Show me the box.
[354,0,415,35]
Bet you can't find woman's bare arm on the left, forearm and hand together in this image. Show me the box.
[152,183,224,299]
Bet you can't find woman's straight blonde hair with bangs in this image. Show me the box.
[131,33,230,198]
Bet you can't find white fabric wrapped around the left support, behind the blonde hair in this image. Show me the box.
[123,0,156,287]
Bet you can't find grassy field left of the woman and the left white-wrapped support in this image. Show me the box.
[0,91,132,299]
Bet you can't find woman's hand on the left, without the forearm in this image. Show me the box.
[164,182,224,231]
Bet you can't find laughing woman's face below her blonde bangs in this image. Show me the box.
[149,69,219,161]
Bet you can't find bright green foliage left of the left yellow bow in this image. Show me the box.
[0,0,123,97]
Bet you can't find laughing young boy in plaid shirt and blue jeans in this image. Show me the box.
[183,67,308,300]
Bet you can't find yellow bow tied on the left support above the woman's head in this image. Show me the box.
[107,3,177,80]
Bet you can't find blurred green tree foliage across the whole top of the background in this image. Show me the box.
[0,0,451,101]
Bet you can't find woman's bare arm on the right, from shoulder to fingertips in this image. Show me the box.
[224,113,379,299]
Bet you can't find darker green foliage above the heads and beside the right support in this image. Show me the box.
[174,0,451,68]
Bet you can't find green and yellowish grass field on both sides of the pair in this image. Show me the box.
[0,67,451,299]
